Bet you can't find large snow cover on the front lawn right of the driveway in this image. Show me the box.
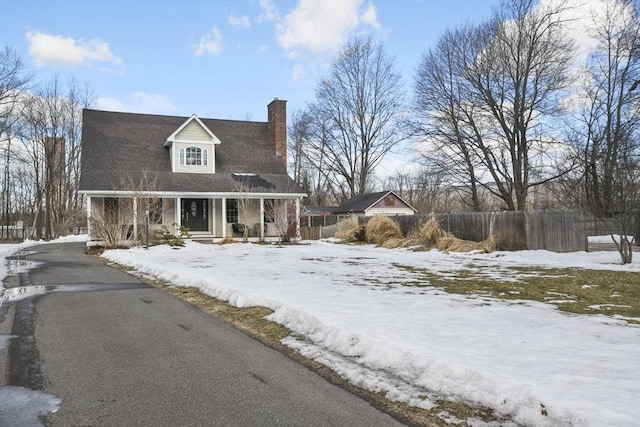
[97,241,640,426]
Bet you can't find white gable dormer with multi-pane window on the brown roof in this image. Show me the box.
[164,114,220,173]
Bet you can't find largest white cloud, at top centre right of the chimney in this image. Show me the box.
[277,0,381,57]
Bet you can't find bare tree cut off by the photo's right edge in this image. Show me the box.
[572,0,640,263]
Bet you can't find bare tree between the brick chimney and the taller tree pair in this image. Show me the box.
[309,38,404,197]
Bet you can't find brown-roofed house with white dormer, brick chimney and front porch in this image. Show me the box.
[79,98,305,244]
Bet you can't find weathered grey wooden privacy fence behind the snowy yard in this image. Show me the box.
[301,209,587,252]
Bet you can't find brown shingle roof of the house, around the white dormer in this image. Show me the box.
[80,110,304,193]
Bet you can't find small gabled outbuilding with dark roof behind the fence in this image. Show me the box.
[334,191,417,219]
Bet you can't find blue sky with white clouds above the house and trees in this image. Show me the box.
[0,0,498,121]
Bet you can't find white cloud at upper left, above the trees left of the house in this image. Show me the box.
[27,31,122,67]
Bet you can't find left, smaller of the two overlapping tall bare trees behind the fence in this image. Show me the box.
[412,27,483,211]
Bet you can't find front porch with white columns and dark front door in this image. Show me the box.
[87,194,300,245]
